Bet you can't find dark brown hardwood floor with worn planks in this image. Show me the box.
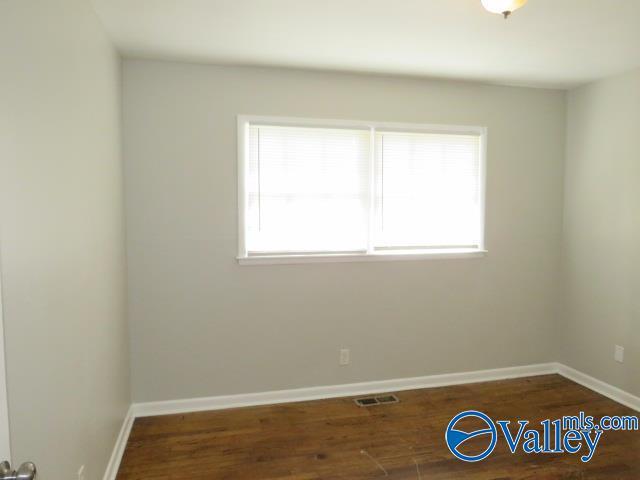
[118,375,640,480]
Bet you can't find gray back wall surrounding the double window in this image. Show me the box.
[124,61,565,401]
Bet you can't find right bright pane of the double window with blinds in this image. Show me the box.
[374,132,481,248]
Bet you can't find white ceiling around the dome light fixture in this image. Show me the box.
[93,0,640,87]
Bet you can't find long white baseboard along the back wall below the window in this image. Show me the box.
[132,363,558,417]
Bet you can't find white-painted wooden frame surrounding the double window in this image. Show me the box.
[237,115,488,265]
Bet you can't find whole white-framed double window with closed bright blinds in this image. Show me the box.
[238,117,486,263]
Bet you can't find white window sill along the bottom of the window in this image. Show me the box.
[238,248,487,265]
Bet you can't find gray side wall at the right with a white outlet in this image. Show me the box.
[560,70,640,395]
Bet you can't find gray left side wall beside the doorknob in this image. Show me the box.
[0,0,130,480]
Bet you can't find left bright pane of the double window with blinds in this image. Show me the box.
[246,125,371,253]
